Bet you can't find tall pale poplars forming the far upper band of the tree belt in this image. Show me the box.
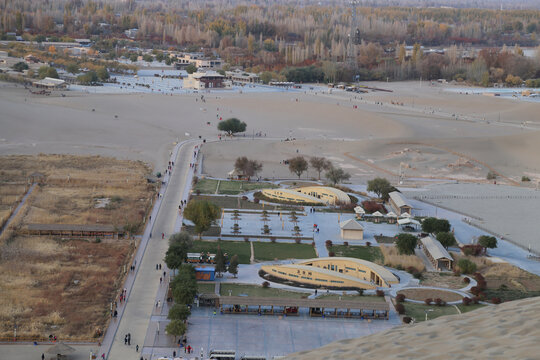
[0,0,540,48]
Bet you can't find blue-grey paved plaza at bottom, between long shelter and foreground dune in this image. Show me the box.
[182,307,400,359]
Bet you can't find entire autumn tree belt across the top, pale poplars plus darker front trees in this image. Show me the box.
[0,0,540,84]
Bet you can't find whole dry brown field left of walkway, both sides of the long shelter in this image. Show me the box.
[0,155,155,340]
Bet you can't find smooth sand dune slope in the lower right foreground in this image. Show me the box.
[286,298,540,360]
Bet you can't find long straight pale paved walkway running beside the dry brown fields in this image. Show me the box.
[99,140,195,359]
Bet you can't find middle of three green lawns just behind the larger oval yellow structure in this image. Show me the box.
[253,241,317,261]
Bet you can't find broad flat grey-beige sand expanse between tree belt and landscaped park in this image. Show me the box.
[0,82,540,180]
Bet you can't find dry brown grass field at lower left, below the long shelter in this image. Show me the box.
[0,237,134,340]
